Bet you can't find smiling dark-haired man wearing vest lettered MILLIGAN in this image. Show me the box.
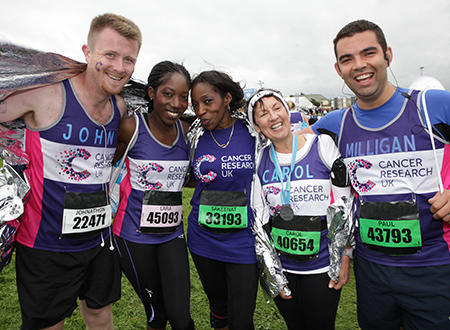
[303,20,450,329]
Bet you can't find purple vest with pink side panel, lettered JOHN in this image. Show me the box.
[17,80,121,252]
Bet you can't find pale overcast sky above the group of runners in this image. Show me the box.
[0,0,450,97]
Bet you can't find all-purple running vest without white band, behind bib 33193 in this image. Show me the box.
[187,120,256,264]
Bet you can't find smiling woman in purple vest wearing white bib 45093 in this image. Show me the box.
[113,61,194,329]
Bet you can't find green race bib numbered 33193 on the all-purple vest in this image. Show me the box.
[198,190,248,232]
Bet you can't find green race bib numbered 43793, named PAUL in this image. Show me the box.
[359,202,422,255]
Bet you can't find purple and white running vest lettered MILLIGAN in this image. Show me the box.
[338,91,450,267]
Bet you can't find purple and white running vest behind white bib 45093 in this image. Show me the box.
[113,114,189,244]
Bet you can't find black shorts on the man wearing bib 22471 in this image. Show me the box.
[16,244,121,329]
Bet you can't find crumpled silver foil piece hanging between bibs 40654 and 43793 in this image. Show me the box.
[327,197,355,282]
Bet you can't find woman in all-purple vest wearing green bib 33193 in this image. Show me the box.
[188,71,258,329]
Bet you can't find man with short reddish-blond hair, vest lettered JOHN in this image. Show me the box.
[0,14,142,329]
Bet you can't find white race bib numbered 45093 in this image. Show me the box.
[140,190,183,234]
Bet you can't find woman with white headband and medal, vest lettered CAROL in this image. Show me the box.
[248,89,350,329]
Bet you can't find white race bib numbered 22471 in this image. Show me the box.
[62,191,112,235]
